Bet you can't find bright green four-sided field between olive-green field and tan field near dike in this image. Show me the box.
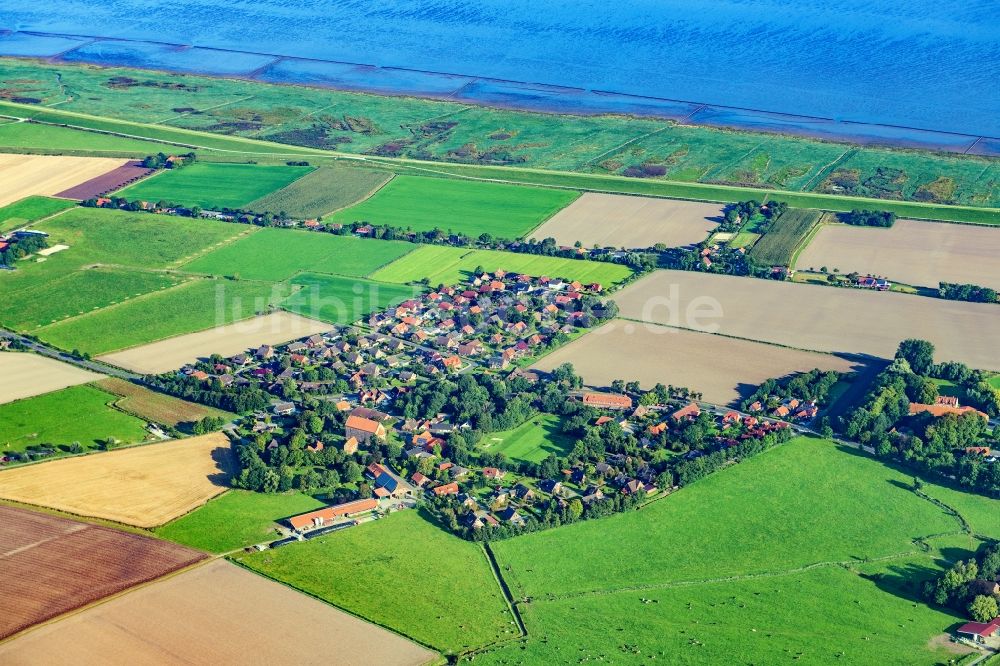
[330,176,577,239]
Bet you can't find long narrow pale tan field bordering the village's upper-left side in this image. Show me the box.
[99,311,333,374]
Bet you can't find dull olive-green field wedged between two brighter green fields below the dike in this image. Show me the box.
[247,166,392,218]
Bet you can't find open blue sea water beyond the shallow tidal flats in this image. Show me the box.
[0,0,1000,136]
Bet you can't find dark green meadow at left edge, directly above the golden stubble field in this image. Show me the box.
[0,385,148,452]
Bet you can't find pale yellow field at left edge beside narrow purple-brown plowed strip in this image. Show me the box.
[0,154,127,206]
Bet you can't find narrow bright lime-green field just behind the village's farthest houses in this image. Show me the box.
[371,245,632,286]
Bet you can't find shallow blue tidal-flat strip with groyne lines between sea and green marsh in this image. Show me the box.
[0,30,1000,157]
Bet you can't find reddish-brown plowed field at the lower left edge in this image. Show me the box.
[0,506,206,640]
